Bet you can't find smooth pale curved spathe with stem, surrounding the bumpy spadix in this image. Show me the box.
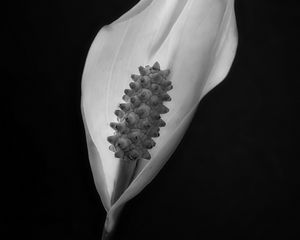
[82,0,237,239]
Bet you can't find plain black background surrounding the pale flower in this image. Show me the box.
[1,0,300,240]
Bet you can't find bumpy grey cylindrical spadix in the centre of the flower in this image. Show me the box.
[107,62,173,161]
